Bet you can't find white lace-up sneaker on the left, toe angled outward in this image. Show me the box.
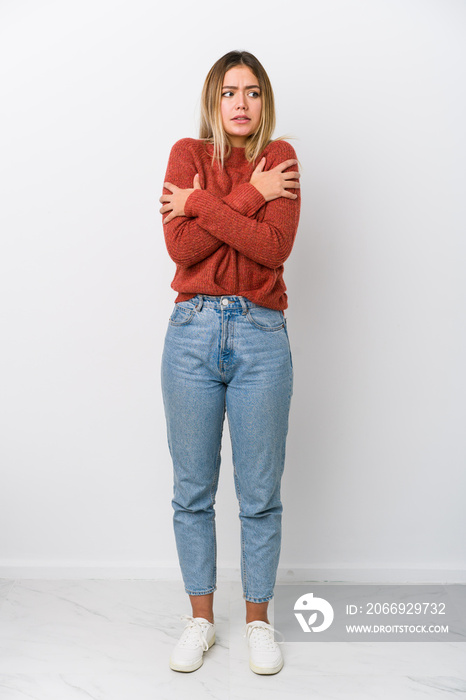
[170,615,215,673]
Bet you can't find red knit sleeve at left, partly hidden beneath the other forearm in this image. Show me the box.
[163,139,226,267]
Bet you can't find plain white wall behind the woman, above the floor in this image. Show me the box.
[0,0,466,580]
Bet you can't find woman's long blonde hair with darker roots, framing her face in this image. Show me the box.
[199,51,275,167]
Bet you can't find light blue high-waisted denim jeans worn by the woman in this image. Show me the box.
[162,294,293,603]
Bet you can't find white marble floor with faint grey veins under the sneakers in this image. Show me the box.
[0,579,466,700]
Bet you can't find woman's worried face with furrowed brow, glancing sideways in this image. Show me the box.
[220,65,262,147]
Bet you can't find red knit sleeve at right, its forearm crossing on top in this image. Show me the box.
[185,141,301,268]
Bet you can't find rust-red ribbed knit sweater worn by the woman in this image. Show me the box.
[163,138,301,310]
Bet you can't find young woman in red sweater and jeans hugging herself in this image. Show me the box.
[160,51,300,674]
